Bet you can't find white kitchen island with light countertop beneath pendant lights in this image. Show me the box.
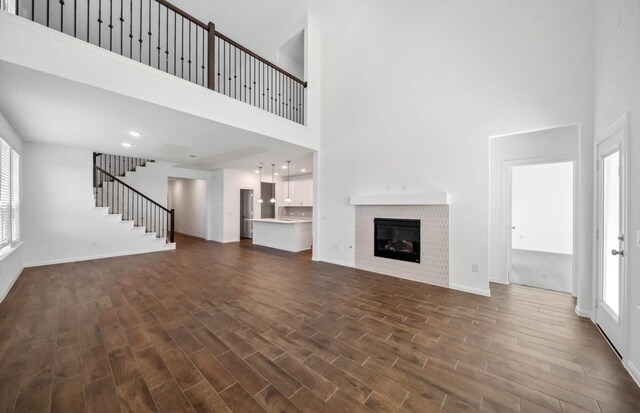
[248,218,312,252]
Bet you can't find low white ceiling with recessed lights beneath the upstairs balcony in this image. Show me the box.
[0,62,313,174]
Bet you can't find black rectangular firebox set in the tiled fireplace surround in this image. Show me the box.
[373,218,420,263]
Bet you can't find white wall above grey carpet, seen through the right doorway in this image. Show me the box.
[511,162,573,254]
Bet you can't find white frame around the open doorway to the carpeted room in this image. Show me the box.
[500,154,579,297]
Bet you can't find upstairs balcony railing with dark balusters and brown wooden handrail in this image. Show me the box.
[0,0,307,124]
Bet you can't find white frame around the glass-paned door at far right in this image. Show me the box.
[591,112,631,361]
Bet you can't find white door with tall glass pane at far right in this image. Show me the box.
[596,124,626,353]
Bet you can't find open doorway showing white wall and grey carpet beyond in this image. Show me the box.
[507,162,574,293]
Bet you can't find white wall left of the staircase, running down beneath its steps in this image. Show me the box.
[22,143,171,266]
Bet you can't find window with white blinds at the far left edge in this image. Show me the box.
[0,139,20,248]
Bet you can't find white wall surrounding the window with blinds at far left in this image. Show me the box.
[0,112,25,302]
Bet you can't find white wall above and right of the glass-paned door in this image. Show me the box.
[586,0,640,384]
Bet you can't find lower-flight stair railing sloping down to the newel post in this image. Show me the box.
[93,163,175,242]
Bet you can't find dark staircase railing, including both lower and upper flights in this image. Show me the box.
[93,153,175,244]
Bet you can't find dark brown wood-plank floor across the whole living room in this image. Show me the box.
[0,233,640,413]
